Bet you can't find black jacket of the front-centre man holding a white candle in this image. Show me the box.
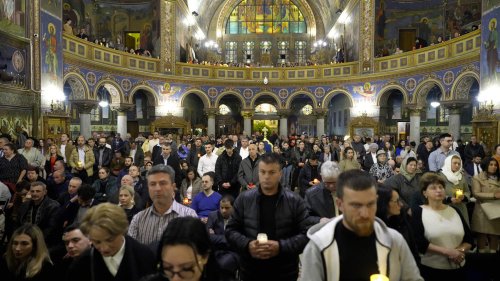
[226,186,311,280]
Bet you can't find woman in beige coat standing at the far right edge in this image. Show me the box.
[472,157,500,253]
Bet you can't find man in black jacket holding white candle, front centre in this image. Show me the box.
[226,153,310,281]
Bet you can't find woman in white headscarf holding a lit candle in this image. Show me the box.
[440,155,470,225]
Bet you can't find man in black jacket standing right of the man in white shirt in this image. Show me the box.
[215,139,241,198]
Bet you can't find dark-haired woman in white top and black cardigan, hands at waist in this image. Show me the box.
[412,173,474,281]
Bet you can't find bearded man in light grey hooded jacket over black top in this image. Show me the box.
[301,170,423,281]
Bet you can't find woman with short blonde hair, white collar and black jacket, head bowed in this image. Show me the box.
[68,203,155,281]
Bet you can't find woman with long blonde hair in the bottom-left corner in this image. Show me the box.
[0,224,53,281]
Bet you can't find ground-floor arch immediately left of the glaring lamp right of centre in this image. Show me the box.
[327,92,352,136]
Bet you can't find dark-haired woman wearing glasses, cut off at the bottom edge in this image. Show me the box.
[142,217,219,281]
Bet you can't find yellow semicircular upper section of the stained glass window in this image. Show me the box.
[226,0,307,34]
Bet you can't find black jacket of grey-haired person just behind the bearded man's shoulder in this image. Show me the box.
[304,183,335,224]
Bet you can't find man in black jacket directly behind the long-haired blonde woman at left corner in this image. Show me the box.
[19,181,59,246]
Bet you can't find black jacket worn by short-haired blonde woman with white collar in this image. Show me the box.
[66,236,156,281]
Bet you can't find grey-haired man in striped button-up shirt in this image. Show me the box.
[128,165,198,246]
